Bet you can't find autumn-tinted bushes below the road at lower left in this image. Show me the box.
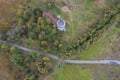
[0,44,53,80]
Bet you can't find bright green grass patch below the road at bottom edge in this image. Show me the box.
[50,64,91,80]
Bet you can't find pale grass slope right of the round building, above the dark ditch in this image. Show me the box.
[68,0,99,39]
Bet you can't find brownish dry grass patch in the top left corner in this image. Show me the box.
[0,0,21,33]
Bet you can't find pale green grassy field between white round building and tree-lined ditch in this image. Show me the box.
[62,0,99,41]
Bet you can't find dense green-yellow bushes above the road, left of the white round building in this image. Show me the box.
[16,2,62,53]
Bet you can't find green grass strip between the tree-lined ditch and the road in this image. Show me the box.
[76,21,120,59]
